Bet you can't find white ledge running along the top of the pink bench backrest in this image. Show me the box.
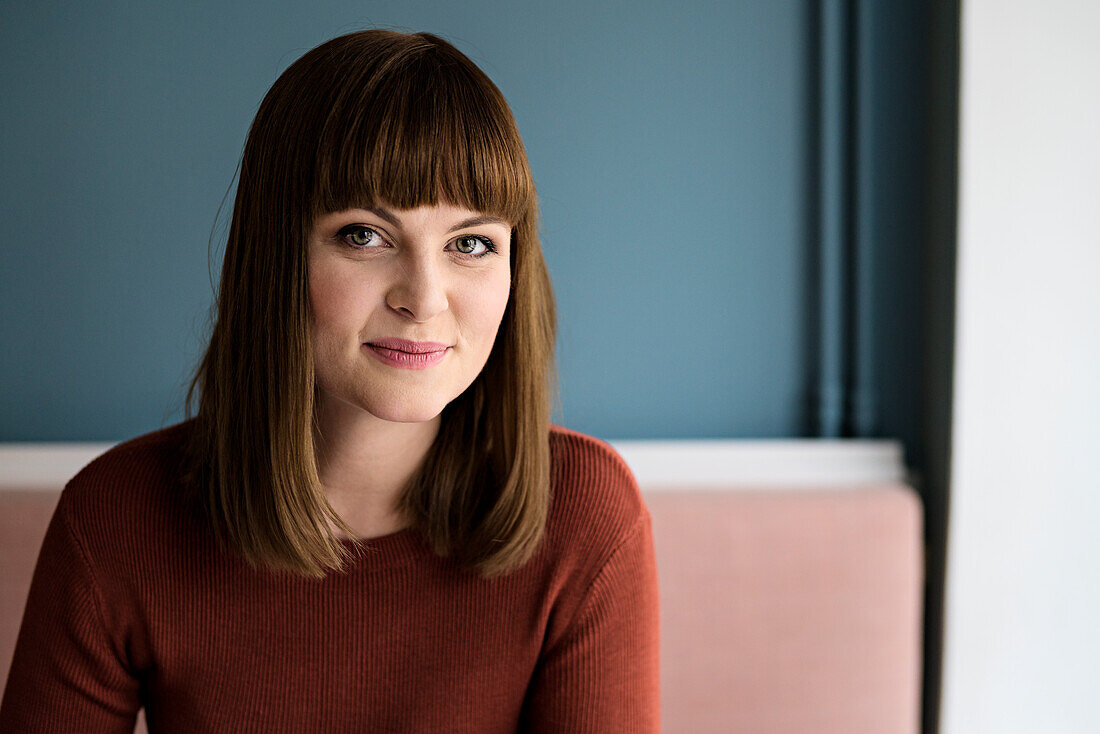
[0,439,909,490]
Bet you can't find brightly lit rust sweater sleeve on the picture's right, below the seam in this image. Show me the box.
[519,512,660,734]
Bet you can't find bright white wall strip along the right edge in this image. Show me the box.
[941,0,1100,734]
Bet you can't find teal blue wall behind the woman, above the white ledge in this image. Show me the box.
[0,0,926,456]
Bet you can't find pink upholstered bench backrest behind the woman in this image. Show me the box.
[0,483,924,734]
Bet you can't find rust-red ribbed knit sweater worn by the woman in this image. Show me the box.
[0,421,659,734]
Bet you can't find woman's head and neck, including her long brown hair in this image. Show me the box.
[187,31,543,578]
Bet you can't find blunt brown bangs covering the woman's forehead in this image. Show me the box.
[310,34,537,227]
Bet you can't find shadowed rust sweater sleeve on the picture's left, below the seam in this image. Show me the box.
[0,492,141,734]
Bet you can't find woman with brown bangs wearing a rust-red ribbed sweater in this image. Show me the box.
[0,30,659,734]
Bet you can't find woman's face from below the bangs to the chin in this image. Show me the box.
[308,205,512,423]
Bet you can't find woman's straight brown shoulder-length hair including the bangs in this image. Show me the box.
[183,30,558,579]
